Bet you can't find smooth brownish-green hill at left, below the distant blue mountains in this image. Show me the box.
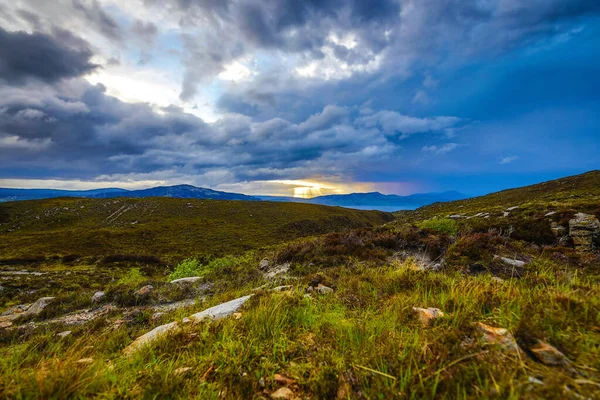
[0,198,392,260]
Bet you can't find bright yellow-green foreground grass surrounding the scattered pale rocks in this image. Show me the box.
[0,260,600,399]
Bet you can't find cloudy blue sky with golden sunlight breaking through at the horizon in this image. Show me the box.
[0,0,600,196]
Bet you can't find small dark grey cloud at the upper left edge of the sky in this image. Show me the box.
[0,28,97,84]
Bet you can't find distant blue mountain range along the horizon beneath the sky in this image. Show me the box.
[0,185,467,211]
